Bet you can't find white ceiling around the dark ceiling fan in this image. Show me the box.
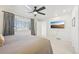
[13,5,74,20]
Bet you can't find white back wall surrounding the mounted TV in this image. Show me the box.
[47,14,72,41]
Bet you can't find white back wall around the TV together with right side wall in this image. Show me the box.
[47,6,79,53]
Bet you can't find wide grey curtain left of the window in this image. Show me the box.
[3,12,15,36]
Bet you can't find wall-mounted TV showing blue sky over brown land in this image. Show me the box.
[49,20,64,28]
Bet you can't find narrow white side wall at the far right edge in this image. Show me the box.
[72,6,79,53]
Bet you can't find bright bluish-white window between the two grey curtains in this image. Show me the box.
[14,16,31,31]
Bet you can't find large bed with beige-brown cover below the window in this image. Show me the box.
[0,36,53,54]
